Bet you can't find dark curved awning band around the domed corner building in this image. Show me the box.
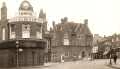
[0,40,46,49]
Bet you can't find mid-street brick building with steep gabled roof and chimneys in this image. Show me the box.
[50,17,93,62]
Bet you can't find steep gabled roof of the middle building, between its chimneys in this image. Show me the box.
[52,22,91,34]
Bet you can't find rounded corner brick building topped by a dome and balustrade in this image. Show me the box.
[0,0,50,67]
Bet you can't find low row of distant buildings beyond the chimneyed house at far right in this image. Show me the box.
[94,34,120,58]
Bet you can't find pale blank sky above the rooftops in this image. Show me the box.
[0,0,120,36]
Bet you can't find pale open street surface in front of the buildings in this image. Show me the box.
[0,59,120,69]
